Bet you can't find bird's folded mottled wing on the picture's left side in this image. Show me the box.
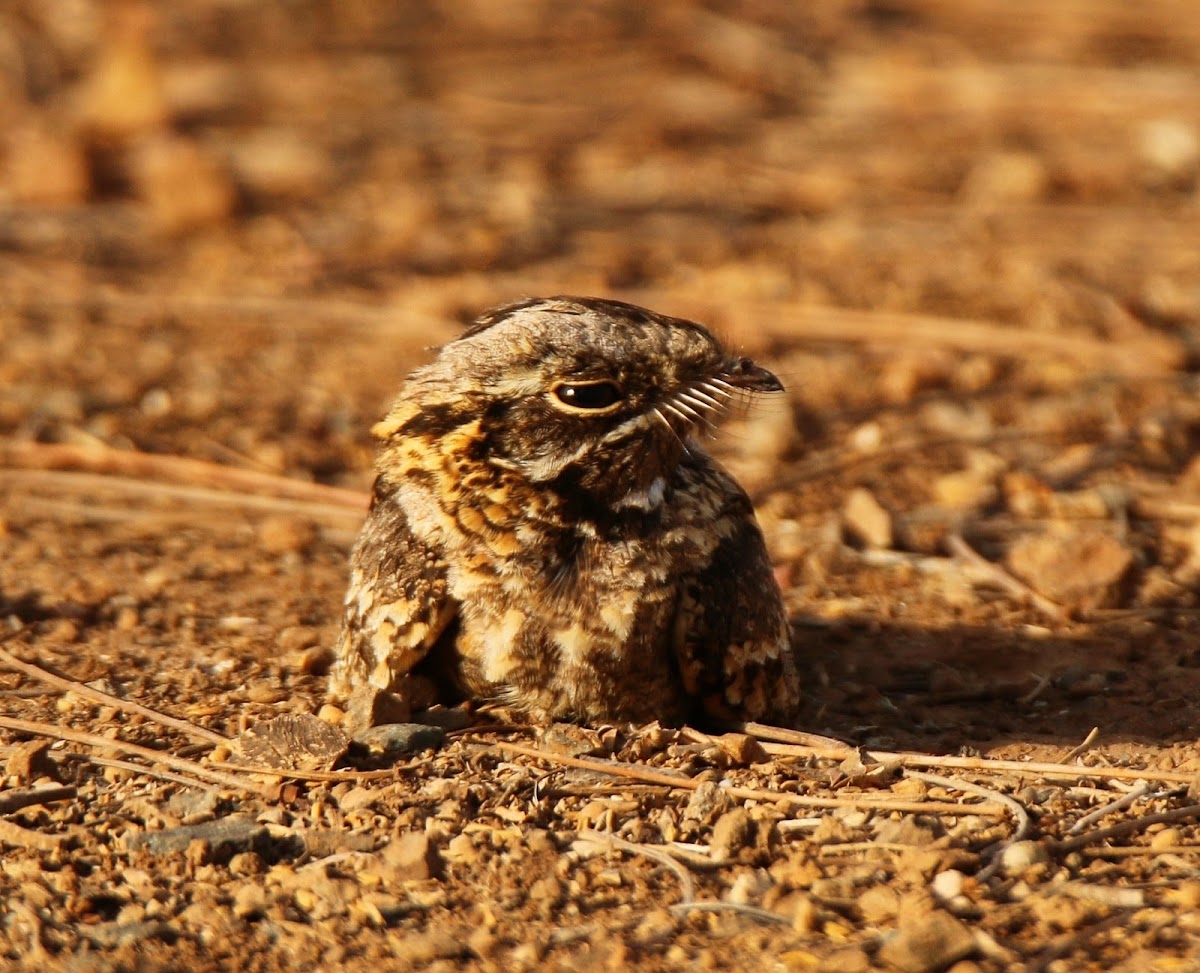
[330,479,457,698]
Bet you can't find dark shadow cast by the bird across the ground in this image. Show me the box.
[794,623,1200,758]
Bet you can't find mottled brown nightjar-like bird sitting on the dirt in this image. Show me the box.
[330,296,800,725]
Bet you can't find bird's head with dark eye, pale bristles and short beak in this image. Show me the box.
[377,298,782,506]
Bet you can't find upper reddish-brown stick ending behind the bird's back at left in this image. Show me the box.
[0,437,367,510]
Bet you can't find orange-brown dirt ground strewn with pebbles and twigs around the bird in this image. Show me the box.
[0,0,1200,973]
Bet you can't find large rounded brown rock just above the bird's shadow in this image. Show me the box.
[1008,527,1134,608]
